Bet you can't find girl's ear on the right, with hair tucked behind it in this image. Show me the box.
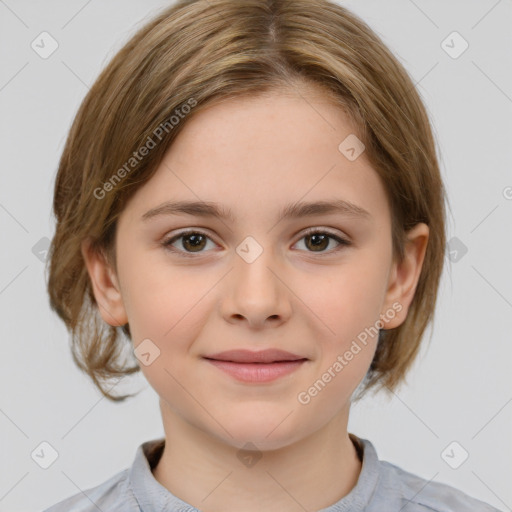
[381,222,430,329]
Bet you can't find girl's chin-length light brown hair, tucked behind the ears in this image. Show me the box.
[48,0,445,400]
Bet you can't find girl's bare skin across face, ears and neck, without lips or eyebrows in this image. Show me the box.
[82,89,429,512]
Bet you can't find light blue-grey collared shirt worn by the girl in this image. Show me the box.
[44,433,500,512]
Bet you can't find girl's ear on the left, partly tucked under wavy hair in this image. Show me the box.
[81,239,128,326]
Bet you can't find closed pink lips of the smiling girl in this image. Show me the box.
[205,349,308,383]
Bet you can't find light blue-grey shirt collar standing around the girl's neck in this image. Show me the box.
[129,433,379,512]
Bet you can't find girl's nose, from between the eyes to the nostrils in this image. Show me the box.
[222,246,293,330]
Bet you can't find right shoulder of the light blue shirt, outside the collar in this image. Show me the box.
[377,460,500,512]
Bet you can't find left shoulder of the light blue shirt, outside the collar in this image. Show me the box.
[43,469,139,512]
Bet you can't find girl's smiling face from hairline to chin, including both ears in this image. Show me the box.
[85,92,428,449]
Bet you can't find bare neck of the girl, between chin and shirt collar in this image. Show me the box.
[153,408,361,512]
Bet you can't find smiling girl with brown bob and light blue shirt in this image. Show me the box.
[43,0,496,512]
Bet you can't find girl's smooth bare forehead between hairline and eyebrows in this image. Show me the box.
[121,91,388,229]
